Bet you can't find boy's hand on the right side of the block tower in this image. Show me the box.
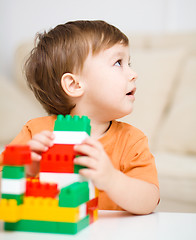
[74,137,116,191]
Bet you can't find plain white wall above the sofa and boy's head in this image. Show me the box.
[0,0,196,77]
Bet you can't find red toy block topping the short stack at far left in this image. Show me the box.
[3,145,31,166]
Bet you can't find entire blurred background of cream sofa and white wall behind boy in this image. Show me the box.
[0,0,196,212]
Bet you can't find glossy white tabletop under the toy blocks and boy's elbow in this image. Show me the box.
[0,211,196,240]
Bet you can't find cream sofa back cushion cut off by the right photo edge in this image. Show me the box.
[157,54,196,154]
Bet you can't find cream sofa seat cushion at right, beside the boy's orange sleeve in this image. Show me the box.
[154,152,196,204]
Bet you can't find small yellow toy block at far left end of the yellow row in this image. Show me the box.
[0,199,21,222]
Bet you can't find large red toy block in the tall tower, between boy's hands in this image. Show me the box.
[40,144,76,173]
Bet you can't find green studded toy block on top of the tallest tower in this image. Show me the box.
[54,115,91,135]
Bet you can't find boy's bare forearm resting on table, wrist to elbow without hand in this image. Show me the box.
[102,169,160,214]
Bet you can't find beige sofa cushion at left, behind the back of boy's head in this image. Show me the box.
[0,77,44,146]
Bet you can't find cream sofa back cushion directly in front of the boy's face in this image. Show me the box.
[121,48,186,146]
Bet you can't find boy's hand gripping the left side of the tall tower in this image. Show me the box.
[27,131,54,176]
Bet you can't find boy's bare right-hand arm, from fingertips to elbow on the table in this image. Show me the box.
[74,138,159,214]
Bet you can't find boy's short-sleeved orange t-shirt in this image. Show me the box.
[0,116,159,210]
